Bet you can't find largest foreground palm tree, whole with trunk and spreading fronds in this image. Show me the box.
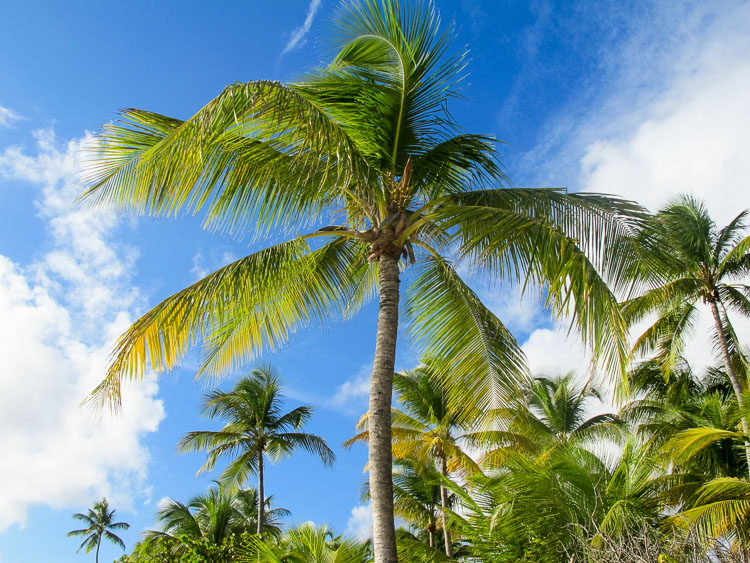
[81,0,640,563]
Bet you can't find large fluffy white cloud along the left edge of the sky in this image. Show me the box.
[0,126,164,530]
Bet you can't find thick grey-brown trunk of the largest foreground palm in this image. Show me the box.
[367,254,399,563]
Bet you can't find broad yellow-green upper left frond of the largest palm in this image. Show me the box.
[81,81,368,232]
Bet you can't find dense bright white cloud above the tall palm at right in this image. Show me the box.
[582,50,750,224]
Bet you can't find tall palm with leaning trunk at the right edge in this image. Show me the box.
[623,195,750,468]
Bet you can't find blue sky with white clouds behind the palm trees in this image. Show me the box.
[0,0,750,563]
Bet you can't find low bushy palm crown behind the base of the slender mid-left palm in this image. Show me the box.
[144,485,290,552]
